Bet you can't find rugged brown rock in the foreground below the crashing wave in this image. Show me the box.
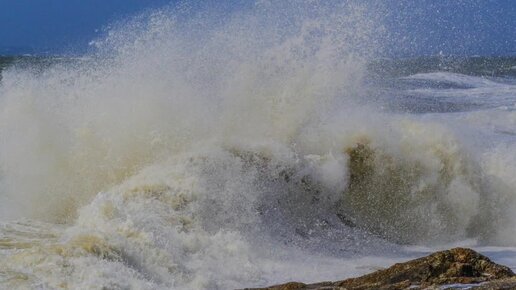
[247,248,516,290]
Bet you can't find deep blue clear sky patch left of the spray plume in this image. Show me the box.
[0,0,169,53]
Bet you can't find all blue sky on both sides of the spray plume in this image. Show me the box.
[0,0,516,56]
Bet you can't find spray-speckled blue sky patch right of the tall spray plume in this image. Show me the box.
[387,0,516,55]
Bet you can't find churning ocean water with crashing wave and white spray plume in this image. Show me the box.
[0,1,516,289]
